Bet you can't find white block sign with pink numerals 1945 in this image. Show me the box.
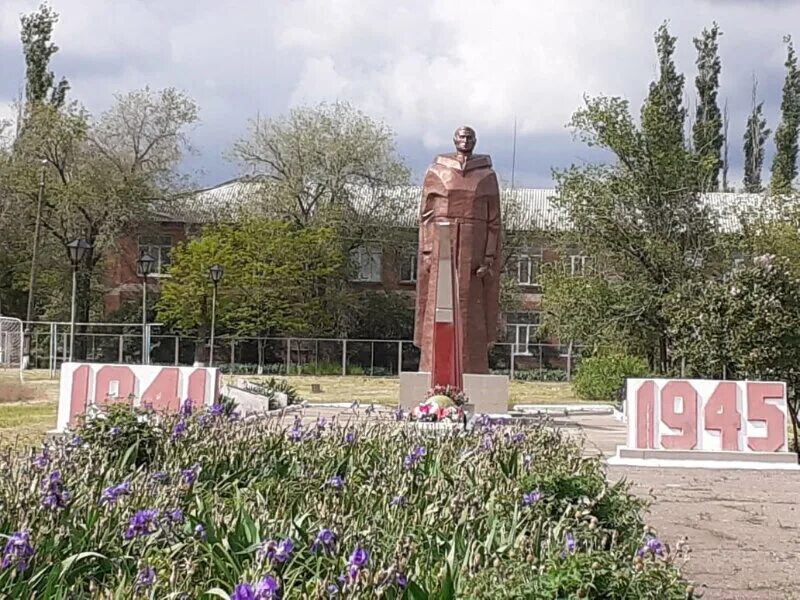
[626,379,788,453]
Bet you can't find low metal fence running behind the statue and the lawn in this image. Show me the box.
[21,322,581,381]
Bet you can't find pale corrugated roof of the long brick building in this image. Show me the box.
[158,179,780,232]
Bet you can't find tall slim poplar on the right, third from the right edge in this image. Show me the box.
[692,23,723,191]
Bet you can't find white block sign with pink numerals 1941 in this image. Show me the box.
[56,363,219,431]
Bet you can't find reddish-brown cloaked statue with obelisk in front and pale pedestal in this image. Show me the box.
[400,127,508,412]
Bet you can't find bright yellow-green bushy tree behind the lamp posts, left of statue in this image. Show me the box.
[157,218,346,360]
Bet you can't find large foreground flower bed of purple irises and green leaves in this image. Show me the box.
[0,406,691,600]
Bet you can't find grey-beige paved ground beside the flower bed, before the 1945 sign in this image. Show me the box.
[562,417,800,600]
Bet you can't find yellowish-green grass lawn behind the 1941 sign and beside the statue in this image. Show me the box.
[0,370,577,443]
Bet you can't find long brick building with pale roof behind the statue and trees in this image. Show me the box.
[105,179,762,363]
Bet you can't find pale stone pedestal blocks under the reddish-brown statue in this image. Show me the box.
[400,371,508,415]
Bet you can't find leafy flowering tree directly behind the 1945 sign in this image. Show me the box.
[669,254,800,454]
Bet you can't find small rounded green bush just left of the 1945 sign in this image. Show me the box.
[572,354,648,404]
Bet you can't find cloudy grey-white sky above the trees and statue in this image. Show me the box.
[0,0,800,187]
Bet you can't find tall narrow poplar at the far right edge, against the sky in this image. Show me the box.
[770,36,800,195]
